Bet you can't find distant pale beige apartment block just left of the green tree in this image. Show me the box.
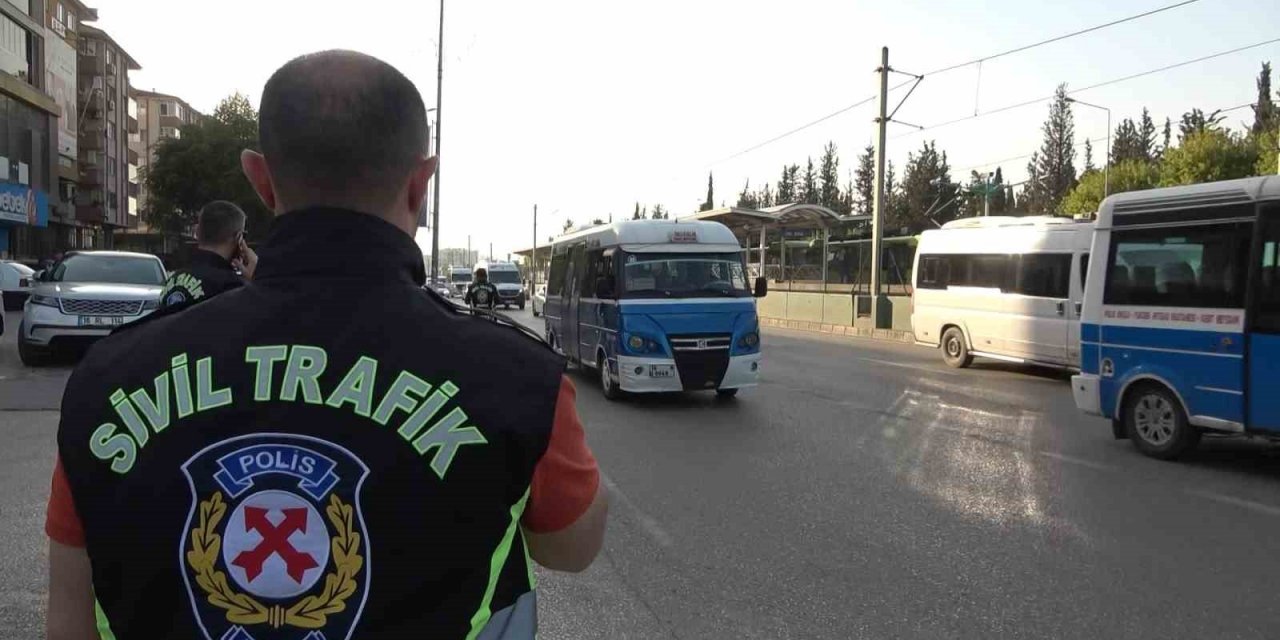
[116,88,204,256]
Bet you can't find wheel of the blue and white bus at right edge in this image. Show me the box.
[1124,384,1201,460]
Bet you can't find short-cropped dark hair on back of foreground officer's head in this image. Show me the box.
[259,50,428,214]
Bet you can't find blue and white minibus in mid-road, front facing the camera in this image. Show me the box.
[543,220,765,399]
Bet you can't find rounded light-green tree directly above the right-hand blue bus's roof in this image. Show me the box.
[1160,129,1258,187]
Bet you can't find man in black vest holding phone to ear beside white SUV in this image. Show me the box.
[160,200,257,308]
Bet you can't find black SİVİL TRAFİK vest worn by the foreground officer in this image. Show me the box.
[58,210,563,640]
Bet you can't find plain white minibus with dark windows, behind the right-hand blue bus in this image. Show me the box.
[911,216,1093,369]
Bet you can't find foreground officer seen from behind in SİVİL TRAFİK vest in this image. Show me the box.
[46,51,607,640]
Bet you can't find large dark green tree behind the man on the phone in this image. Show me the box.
[141,93,273,239]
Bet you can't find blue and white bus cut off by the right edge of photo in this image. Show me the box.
[1071,175,1280,458]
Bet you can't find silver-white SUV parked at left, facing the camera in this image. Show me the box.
[18,251,165,366]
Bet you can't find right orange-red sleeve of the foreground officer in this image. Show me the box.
[522,378,600,534]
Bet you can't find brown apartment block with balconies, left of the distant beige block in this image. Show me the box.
[76,24,141,248]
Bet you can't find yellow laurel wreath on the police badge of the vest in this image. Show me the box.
[187,492,365,628]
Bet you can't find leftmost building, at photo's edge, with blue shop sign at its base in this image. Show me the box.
[0,0,68,259]
